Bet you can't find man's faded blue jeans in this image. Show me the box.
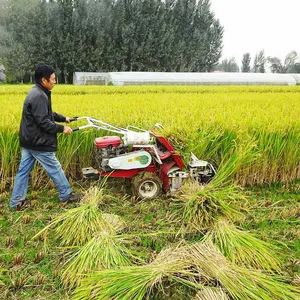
[9,148,71,207]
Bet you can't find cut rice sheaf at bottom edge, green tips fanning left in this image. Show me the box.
[73,245,199,300]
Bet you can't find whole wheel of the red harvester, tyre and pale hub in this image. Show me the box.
[131,172,162,199]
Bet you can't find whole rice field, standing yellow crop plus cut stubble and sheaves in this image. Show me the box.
[0,85,300,300]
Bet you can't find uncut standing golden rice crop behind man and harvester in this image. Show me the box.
[0,85,300,190]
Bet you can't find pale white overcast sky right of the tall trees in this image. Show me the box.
[211,0,300,65]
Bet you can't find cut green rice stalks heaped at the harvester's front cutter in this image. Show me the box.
[179,138,255,231]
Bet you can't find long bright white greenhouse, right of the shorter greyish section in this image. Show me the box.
[108,72,296,86]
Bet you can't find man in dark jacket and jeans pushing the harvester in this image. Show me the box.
[9,64,80,210]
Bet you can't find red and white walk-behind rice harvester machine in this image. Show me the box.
[71,117,216,199]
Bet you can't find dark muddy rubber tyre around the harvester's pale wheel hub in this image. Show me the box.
[131,172,162,199]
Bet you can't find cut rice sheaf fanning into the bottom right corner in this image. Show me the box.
[188,243,300,300]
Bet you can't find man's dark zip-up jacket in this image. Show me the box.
[19,84,66,152]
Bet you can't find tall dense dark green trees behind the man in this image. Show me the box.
[0,0,223,83]
